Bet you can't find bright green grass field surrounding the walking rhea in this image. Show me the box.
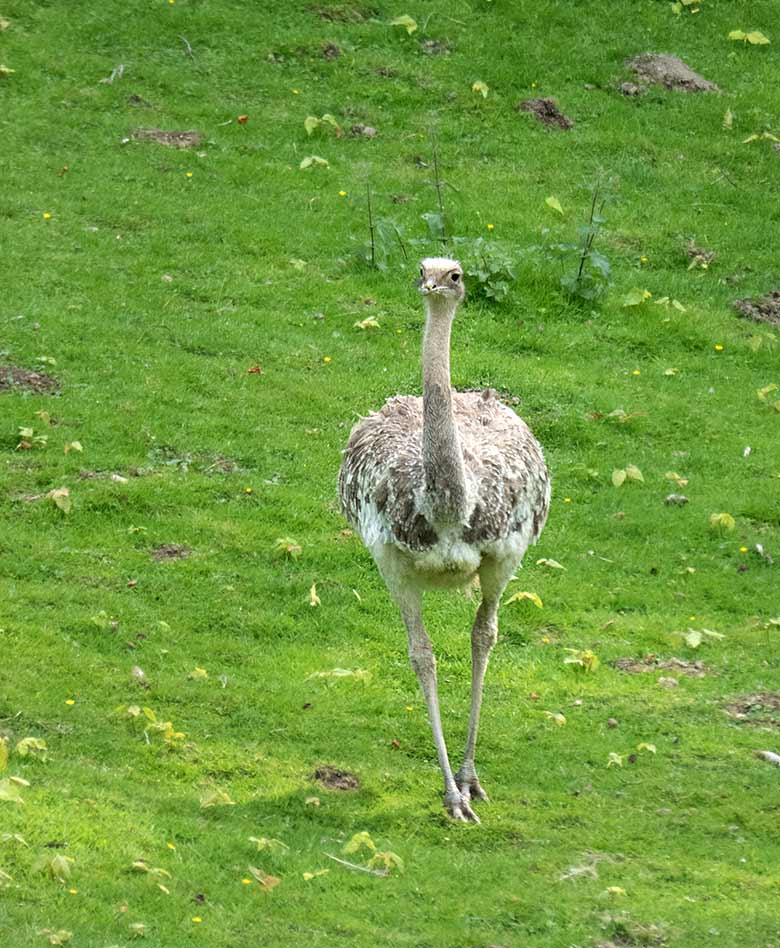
[0,0,780,948]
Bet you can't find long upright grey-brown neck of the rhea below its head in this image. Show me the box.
[423,296,468,520]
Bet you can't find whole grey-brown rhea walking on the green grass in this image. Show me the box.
[339,257,550,823]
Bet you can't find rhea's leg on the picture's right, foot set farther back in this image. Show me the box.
[455,559,514,800]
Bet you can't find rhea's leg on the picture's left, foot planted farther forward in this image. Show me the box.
[394,590,479,823]
